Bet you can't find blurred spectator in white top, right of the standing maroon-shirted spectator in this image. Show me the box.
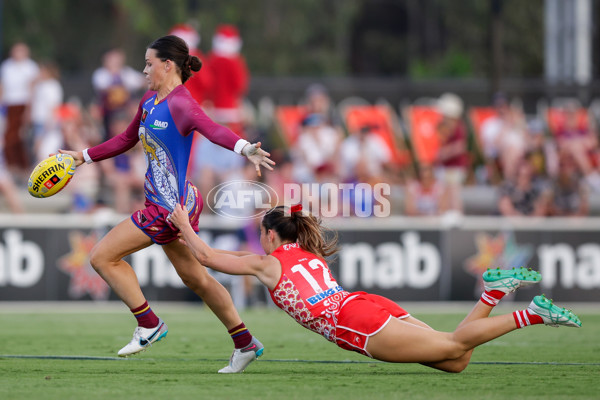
[481,93,529,182]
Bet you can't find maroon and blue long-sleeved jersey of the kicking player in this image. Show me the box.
[87,85,245,211]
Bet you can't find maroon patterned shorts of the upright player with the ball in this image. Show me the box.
[131,183,203,244]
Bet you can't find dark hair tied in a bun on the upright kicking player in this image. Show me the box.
[148,35,202,83]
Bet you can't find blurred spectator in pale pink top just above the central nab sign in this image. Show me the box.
[404,164,452,217]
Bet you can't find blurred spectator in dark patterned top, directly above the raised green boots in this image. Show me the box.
[498,157,552,217]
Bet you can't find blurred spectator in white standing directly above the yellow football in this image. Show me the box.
[31,62,63,162]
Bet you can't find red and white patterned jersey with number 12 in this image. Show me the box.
[269,243,350,342]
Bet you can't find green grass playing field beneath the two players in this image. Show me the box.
[0,304,600,400]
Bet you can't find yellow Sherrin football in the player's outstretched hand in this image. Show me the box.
[27,153,75,197]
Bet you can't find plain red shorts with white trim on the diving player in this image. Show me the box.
[336,292,410,357]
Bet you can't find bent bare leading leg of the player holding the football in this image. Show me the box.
[90,218,152,309]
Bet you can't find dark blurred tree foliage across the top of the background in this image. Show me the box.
[2,0,544,78]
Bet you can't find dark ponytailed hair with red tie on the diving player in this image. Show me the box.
[262,206,338,258]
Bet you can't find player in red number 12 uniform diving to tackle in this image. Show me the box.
[169,205,581,372]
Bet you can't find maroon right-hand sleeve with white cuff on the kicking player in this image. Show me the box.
[169,89,247,153]
